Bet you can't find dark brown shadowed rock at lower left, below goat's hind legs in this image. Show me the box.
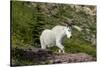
[12,48,52,61]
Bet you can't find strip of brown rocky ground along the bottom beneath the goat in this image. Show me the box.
[12,48,96,65]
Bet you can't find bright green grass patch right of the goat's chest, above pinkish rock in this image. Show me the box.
[64,38,96,57]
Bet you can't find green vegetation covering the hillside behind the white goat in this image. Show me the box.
[11,1,96,65]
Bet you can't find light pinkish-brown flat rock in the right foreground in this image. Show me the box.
[54,53,94,63]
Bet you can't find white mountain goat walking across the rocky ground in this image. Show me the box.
[40,21,81,53]
